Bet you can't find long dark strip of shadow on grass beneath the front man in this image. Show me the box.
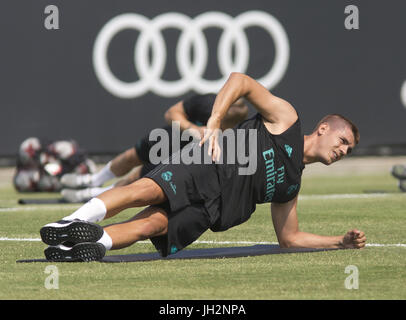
[17,245,336,263]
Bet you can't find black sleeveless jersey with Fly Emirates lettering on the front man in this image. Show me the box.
[212,113,304,231]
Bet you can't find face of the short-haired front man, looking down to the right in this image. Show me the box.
[318,123,355,165]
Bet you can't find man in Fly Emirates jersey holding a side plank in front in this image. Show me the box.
[40,73,366,261]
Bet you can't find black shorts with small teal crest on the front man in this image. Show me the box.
[145,145,221,257]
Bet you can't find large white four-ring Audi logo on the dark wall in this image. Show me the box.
[93,11,289,98]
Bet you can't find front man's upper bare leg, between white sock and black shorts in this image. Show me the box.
[97,178,167,219]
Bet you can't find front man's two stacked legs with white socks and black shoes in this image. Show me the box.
[44,178,168,261]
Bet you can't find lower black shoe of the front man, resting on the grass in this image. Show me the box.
[44,242,106,262]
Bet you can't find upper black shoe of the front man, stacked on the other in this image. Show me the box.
[40,220,103,246]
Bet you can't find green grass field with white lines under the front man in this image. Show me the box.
[0,161,406,300]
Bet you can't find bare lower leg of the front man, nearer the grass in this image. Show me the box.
[104,206,168,250]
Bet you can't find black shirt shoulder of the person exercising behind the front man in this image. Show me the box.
[183,93,216,126]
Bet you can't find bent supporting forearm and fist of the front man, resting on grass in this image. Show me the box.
[271,196,366,249]
